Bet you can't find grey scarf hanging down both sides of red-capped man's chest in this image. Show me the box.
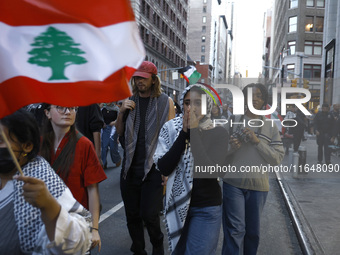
[123,93,169,178]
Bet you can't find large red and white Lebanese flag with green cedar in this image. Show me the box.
[0,0,145,118]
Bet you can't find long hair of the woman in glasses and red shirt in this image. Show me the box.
[40,104,77,183]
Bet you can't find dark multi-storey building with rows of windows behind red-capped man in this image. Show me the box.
[131,0,189,99]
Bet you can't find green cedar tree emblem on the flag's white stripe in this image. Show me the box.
[28,27,87,81]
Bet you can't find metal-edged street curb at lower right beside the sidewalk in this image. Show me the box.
[276,172,325,255]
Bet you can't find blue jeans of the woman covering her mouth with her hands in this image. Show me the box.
[172,205,222,255]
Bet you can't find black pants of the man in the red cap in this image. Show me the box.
[120,166,164,254]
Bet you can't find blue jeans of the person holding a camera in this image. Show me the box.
[222,182,268,255]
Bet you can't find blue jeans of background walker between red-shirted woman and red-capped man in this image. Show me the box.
[101,125,120,165]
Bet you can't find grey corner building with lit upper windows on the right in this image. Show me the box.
[271,0,325,108]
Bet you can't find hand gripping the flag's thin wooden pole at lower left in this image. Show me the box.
[13,176,56,210]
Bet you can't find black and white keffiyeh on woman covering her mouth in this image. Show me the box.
[154,85,212,252]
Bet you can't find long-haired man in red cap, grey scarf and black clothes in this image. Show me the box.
[116,61,175,255]
